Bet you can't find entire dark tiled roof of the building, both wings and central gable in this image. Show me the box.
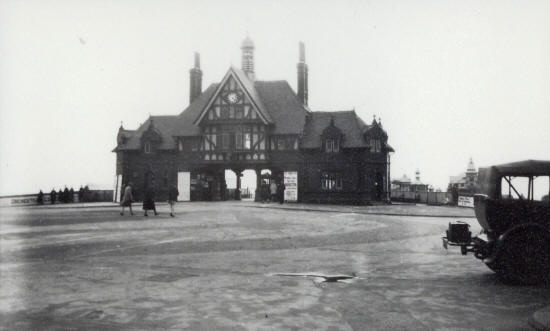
[115,67,393,151]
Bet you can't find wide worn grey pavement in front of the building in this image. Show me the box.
[0,203,550,330]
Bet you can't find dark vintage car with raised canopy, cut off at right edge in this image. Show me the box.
[443,160,550,284]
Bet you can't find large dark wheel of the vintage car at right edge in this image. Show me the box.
[497,231,550,285]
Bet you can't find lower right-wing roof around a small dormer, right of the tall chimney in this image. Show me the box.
[302,110,368,148]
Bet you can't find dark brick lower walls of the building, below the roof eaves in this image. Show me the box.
[117,144,387,204]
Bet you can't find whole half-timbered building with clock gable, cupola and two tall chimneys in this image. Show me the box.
[114,38,393,204]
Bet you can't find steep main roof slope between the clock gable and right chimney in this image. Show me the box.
[254,80,308,135]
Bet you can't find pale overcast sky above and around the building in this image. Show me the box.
[0,0,550,195]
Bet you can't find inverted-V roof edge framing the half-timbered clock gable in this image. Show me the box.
[193,67,273,125]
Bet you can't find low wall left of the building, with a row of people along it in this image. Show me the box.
[0,190,113,207]
